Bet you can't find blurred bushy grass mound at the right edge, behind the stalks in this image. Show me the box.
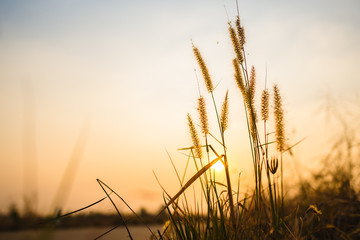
[288,96,360,239]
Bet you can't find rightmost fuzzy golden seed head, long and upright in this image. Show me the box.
[274,84,285,152]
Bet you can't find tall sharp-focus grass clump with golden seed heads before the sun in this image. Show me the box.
[161,14,293,239]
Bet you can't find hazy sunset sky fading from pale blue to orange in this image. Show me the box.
[0,0,360,213]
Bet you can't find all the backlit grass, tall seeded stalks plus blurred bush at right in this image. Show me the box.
[6,6,360,240]
